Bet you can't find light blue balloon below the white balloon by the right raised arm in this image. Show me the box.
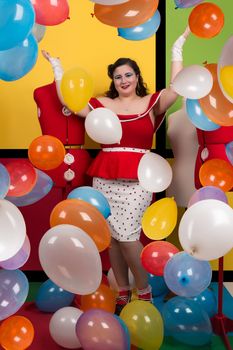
[186,98,220,131]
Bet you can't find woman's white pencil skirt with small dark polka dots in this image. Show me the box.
[93,177,152,242]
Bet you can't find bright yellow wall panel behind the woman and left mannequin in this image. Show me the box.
[0,0,155,149]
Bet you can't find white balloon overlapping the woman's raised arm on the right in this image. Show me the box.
[172,64,213,99]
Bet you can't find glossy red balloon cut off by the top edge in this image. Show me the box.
[31,0,69,26]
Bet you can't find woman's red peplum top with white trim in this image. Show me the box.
[87,92,164,180]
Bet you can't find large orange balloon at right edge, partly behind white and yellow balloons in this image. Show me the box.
[199,63,233,126]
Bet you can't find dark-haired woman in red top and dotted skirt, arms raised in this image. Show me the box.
[42,27,190,313]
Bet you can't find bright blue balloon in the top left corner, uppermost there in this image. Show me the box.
[0,0,35,50]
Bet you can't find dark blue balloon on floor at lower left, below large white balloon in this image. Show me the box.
[35,279,75,312]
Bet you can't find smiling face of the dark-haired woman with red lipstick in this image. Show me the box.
[113,64,138,96]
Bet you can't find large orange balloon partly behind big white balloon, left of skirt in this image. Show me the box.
[50,199,111,252]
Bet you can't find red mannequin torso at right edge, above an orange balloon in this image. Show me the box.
[195,126,233,188]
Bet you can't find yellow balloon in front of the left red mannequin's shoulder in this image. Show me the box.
[60,67,93,112]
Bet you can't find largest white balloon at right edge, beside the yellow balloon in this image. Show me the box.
[178,199,233,260]
